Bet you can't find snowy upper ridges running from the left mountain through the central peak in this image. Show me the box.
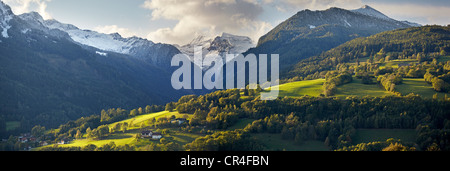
[1,3,255,68]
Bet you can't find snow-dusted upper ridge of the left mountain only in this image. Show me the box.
[0,8,180,69]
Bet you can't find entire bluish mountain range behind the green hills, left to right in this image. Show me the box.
[0,2,424,134]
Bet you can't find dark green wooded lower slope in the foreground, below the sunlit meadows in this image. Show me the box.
[10,90,450,151]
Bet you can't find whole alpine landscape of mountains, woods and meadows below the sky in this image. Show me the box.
[0,2,450,151]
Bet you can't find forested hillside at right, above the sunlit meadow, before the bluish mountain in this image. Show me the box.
[284,26,450,79]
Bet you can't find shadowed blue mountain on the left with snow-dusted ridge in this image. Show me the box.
[0,2,198,129]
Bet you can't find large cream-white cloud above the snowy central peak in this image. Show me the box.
[143,0,272,45]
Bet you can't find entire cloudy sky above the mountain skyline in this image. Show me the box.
[2,0,450,45]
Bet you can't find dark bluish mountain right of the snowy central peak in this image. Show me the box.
[246,5,418,73]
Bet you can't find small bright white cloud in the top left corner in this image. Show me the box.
[3,0,52,19]
